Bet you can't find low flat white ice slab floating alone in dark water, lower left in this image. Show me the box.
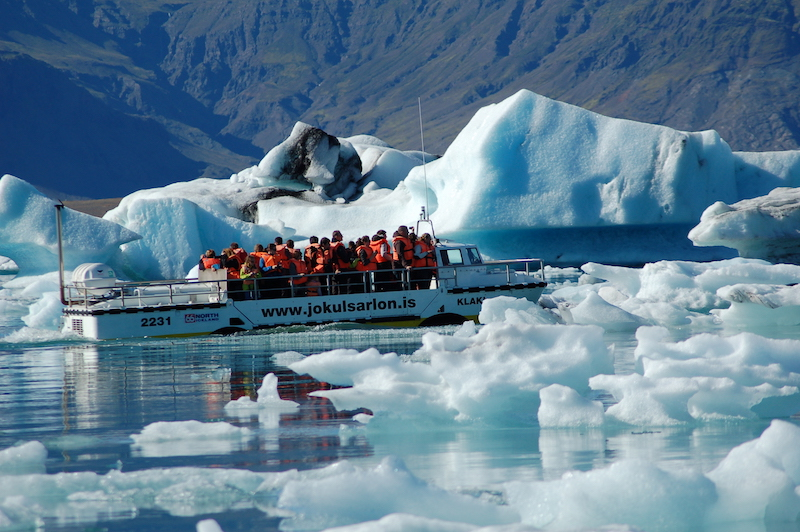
[131,420,253,457]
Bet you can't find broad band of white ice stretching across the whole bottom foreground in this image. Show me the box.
[0,420,800,532]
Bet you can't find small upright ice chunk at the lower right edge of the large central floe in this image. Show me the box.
[538,384,605,427]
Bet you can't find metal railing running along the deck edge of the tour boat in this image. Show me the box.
[64,259,544,309]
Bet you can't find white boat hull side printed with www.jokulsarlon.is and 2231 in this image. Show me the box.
[62,282,546,340]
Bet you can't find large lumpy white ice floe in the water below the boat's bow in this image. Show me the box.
[290,322,613,421]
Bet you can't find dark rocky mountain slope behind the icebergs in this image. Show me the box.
[0,0,800,198]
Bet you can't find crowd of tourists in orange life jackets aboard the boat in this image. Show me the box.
[199,225,436,299]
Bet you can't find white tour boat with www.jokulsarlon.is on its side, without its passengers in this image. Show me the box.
[58,205,547,340]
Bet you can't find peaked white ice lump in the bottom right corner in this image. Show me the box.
[707,420,800,524]
